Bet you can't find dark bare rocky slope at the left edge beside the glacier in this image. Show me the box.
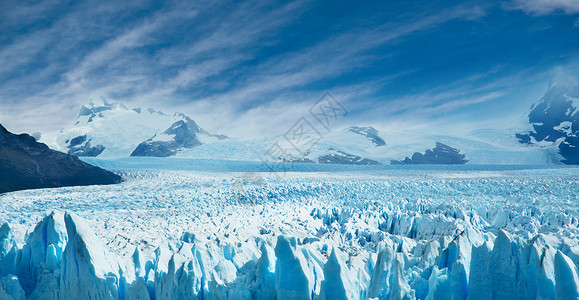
[0,125,121,193]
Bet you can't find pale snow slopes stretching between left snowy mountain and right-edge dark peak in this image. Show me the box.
[176,128,562,165]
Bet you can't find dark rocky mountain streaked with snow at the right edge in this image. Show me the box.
[516,82,579,165]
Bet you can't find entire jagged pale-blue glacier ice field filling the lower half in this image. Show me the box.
[0,159,579,299]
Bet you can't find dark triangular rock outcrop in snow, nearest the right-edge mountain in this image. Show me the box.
[392,142,468,165]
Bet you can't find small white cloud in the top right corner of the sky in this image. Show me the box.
[507,0,579,15]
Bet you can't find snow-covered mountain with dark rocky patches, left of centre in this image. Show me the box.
[42,98,227,157]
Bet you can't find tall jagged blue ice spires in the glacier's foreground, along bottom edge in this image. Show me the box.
[0,211,579,299]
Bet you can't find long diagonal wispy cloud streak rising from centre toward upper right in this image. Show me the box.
[186,6,484,109]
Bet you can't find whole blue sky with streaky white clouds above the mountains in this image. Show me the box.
[0,0,579,137]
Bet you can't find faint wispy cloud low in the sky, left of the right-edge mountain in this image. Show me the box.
[355,66,553,131]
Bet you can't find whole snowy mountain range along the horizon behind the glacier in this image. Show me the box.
[37,88,579,165]
